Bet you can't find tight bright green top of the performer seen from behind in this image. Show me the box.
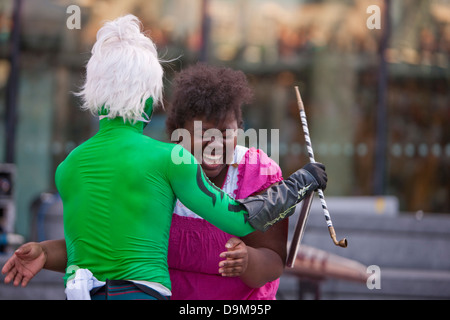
[55,118,255,289]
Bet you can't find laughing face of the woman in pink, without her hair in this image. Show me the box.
[184,113,238,182]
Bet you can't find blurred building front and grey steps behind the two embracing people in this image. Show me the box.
[0,0,450,299]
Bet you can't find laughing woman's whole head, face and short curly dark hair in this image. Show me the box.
[166,63,253,187]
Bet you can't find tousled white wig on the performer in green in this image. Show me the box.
[77,14,163,123]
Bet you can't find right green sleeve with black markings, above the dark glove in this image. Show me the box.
[168,145,255,237]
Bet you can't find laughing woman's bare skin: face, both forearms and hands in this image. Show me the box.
[2,115,288,288]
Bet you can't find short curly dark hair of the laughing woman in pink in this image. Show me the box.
[166,63,253,136]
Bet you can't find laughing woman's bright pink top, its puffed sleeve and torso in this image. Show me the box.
[168,148,283,300]
